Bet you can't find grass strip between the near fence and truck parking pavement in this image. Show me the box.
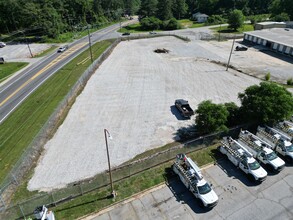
[52,145,218,220]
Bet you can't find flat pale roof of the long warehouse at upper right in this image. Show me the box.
[244,28,293,47]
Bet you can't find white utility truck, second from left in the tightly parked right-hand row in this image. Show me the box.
[238,130,285,172]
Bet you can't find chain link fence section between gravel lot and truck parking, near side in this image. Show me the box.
[0,126,247,219]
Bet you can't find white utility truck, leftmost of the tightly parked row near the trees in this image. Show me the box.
[218,137,268,182]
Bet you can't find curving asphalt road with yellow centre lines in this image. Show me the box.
[0,20,135,124]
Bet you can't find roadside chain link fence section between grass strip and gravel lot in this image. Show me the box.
[0,39,120,212]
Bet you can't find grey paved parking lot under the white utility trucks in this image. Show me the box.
[83,159,293,220]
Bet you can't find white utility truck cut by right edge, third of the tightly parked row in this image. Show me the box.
[256,126,293,162]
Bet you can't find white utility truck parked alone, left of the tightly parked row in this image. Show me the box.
[172,154,219,208]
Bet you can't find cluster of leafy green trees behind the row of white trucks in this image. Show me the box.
[195,82,293,134]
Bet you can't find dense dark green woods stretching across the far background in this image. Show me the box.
[0,0,293,38]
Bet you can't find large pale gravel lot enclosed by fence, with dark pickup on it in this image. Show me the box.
[28,37,260,191]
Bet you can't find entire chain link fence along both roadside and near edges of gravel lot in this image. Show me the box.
[0,33,249,219]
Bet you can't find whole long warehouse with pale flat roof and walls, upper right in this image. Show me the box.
[243,28,293,56]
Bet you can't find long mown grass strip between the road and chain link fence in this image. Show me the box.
[0,40,112,183]
